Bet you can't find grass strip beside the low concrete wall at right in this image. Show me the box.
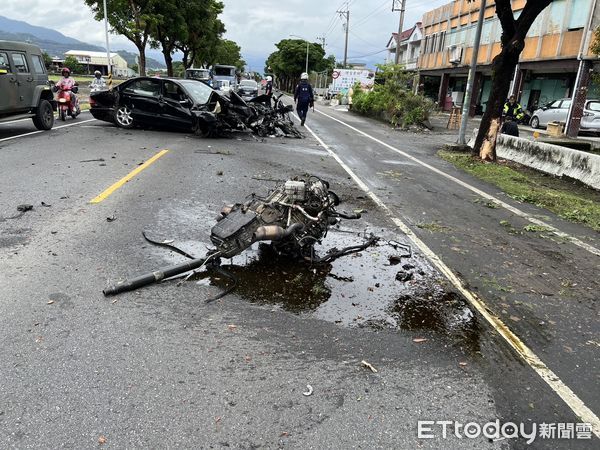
[438,150,600,231]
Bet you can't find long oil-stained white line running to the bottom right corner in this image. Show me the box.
[296,117,600,438]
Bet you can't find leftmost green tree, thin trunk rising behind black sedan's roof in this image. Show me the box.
[85,0,162,75]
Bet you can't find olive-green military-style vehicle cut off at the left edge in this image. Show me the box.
[0,41,56,130]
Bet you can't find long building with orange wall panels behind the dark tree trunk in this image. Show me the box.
[419,0,599,115]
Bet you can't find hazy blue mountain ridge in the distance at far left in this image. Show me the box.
[0,16,165,69]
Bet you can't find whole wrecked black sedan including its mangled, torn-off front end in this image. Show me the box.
[90,77,302,138]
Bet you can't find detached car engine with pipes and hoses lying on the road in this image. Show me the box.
[103,177,378,298]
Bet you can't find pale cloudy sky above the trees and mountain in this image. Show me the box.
[0,0,450,71]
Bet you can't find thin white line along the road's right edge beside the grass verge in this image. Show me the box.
[315,106,600,256]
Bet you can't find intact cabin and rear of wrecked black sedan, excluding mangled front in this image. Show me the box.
[90,77,225,131]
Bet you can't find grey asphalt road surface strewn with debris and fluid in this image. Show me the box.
[0,107,600,448]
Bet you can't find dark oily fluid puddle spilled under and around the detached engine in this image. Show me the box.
[149,201,481,351]
